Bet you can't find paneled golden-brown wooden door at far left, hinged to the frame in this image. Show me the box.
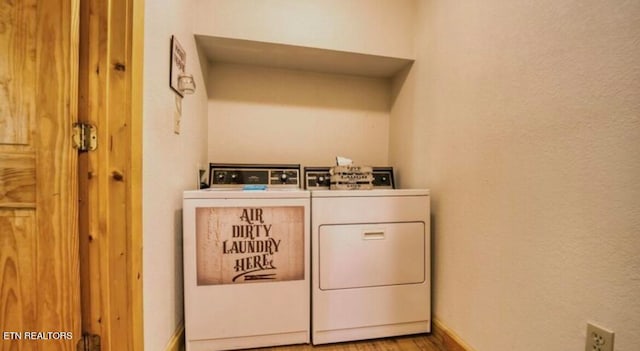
[0,0,81,351]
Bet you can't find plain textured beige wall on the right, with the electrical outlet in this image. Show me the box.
[390,0,640,351]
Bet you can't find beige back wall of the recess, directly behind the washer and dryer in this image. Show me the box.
[208,64,390,166]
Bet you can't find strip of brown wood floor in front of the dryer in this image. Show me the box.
[254,334,448,351]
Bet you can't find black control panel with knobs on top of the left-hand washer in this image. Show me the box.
[209,163,300,188]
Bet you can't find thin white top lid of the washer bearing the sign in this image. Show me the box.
[183,188,309,199]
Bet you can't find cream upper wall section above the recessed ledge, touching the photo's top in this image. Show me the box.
[195,0,416,58]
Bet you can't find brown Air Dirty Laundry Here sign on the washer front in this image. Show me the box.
[196,206,304,285]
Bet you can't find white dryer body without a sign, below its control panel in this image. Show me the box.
[311,189,431,344]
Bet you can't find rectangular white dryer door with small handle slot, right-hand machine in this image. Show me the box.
[318,222,428,290]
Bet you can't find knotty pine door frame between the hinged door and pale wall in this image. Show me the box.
[77,0,144,351]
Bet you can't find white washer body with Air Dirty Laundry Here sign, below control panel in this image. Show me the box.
[183,189,310,351]
